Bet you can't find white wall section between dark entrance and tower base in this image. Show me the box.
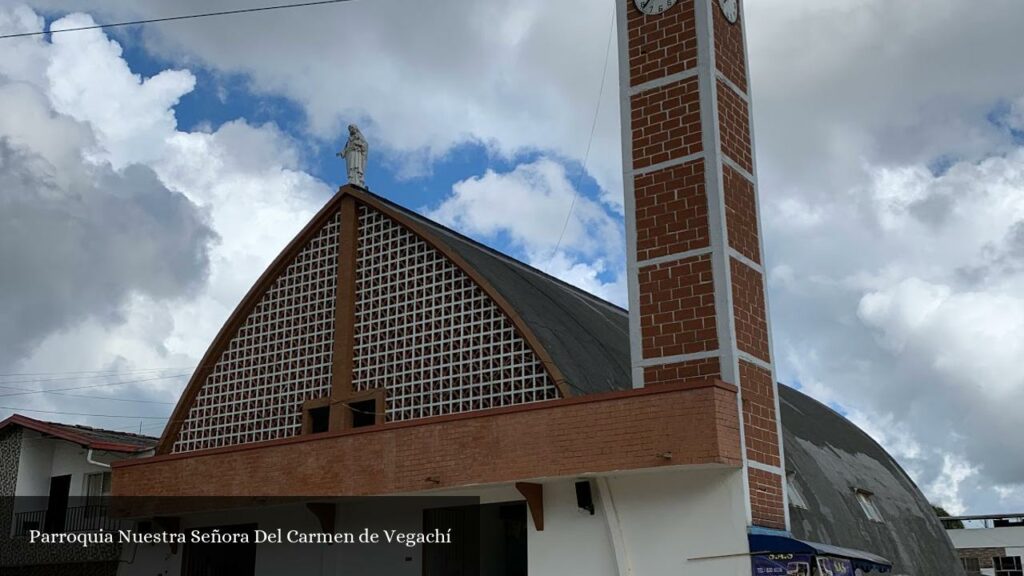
[529,469,751,576]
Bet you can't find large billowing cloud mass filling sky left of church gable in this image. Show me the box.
[0,8,331,433]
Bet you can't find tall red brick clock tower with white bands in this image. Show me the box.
[615,0,790,530]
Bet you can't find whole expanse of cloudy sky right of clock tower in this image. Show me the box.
[748,0,1024,512]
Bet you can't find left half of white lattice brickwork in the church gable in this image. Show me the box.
[174,214,340,452]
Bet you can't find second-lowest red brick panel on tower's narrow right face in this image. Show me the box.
[739,360,781,466]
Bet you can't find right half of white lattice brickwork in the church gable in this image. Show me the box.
[353,206,558,421]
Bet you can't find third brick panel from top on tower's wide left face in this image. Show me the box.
[633,160,710,261]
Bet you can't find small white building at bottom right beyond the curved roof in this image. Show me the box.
[941,513,1024,576]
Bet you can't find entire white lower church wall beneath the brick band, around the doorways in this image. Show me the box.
[119,468,751,576]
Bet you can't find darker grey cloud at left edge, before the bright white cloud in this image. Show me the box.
[0,8,214,367]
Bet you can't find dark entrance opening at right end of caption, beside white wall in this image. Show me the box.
[423,502,526,576]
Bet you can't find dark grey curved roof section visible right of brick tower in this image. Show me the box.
[778,385,959,575]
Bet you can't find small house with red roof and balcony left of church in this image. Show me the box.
[0,414,157,575]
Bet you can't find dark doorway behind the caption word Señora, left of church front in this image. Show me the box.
[181,524,256,576]
